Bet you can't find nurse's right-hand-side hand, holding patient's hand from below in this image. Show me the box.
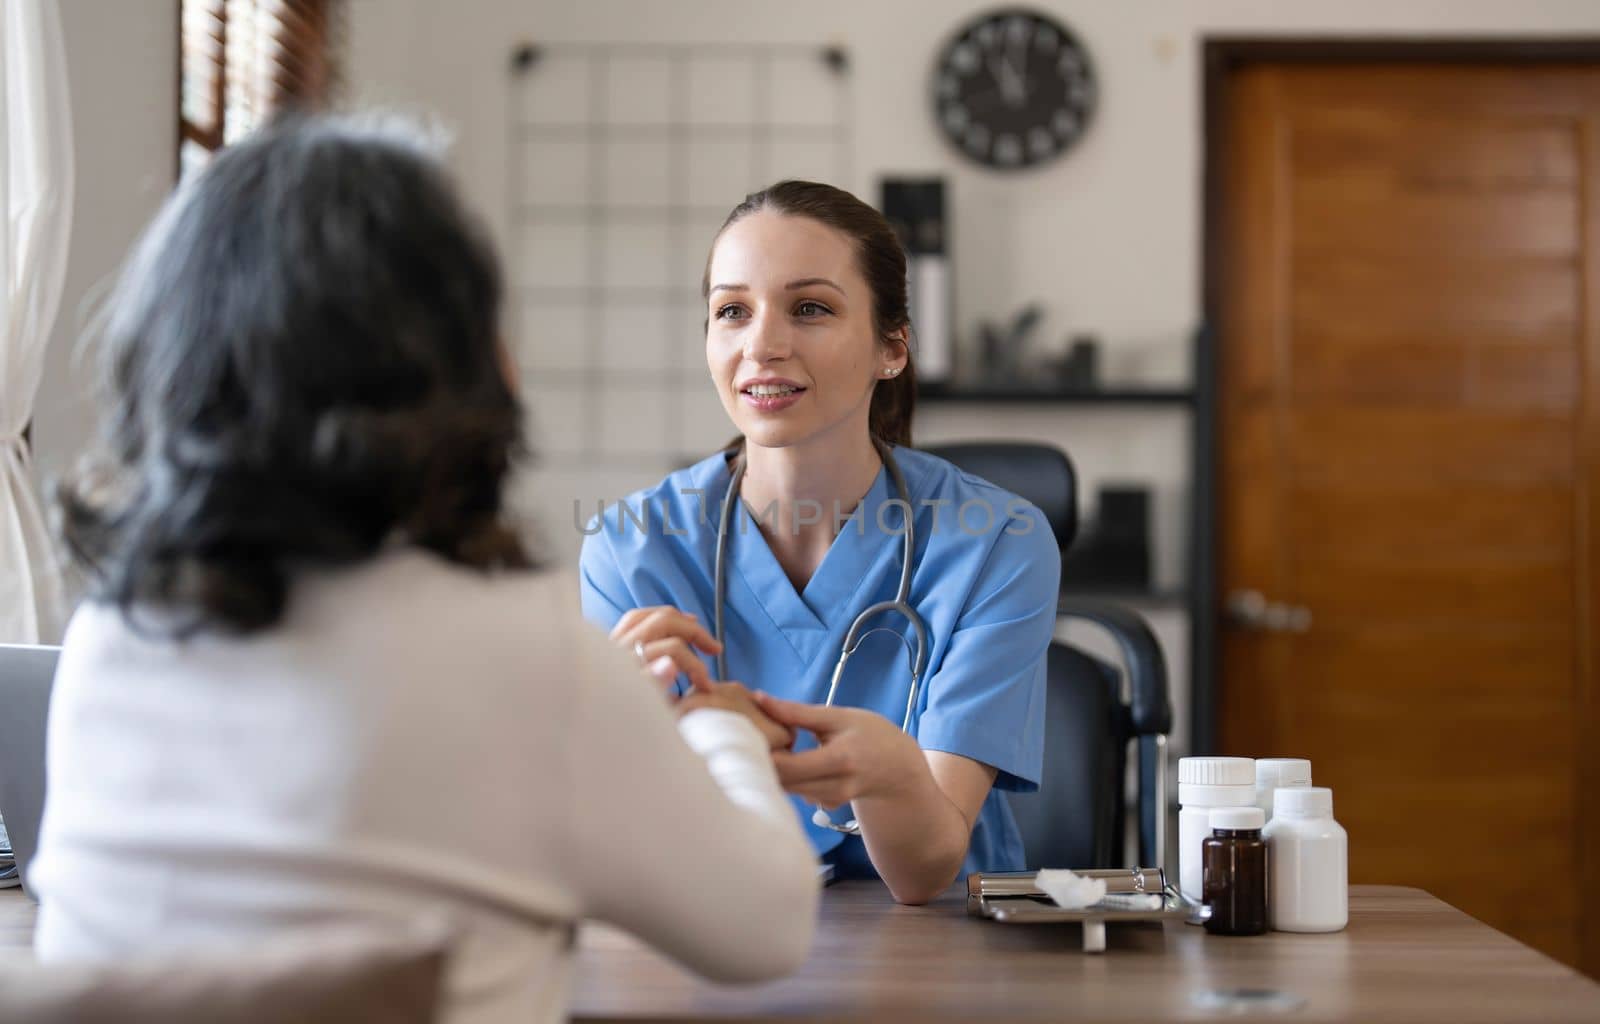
[752,691,928,810]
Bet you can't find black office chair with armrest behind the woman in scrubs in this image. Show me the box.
[925,442,1173,869]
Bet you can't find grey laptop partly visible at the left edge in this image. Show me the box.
[0,643,61,888]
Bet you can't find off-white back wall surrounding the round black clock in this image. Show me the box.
[349,0,1600,749]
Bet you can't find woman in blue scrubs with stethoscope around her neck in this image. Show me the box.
[581,181,1061,902]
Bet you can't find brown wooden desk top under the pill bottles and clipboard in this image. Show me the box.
[9,882,1600,1024]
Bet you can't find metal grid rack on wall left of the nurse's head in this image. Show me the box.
[507,45,851,473]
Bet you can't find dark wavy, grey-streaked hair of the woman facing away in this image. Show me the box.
[54,117,531,634]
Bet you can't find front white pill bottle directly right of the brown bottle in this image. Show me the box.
[1261,786,1350,931]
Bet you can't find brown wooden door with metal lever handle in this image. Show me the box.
[1213,62,1600,973]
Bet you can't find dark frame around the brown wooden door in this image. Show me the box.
[1190,35,1600,978]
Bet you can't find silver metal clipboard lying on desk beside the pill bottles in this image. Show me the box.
[966,867,1194,954]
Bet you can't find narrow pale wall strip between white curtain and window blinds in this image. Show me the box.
[34,0,178,496]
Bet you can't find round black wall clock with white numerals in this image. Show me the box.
[933,8,1094,168]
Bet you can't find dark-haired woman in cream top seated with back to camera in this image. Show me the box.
[30,113,816,1021]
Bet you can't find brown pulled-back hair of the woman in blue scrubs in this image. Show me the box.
[701,181,917,448]
